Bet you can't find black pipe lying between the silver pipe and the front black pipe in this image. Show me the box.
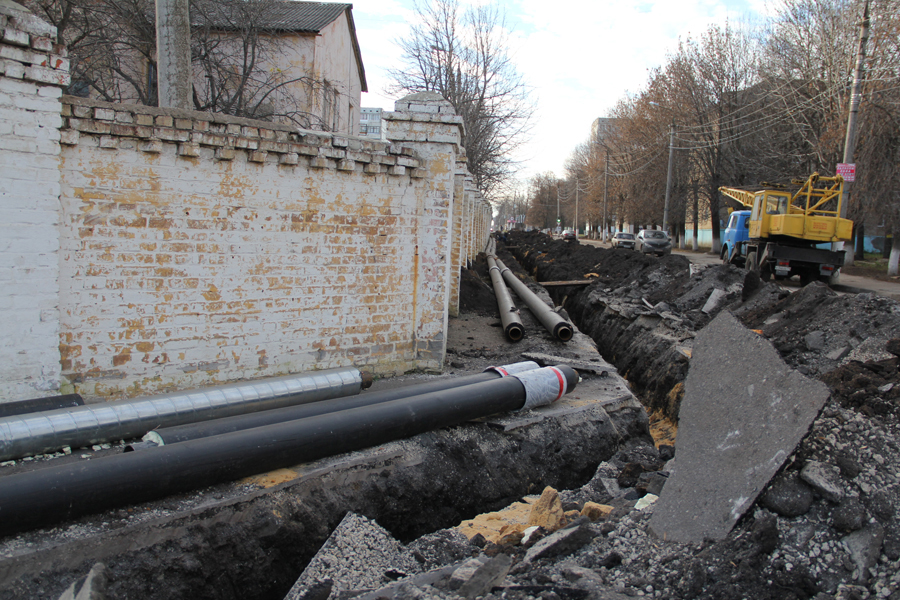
[134,360,540,452]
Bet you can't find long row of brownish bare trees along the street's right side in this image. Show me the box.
[516,0,900,270]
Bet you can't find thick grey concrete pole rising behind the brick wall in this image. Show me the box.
[156,0,191,110]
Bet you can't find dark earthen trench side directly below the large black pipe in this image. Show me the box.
[0,370,643,600]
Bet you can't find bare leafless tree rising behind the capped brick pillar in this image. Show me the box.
[390,0,534,198]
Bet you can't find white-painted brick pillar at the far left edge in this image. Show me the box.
[0,4,69,400]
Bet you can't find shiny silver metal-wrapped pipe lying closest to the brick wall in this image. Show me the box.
[0,368,372,460]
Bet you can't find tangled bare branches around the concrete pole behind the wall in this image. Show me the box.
[22,0,340,130]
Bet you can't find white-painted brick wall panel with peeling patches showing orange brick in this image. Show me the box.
[50,97,468,397]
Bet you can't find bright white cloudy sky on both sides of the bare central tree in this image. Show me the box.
[351,0,774,191]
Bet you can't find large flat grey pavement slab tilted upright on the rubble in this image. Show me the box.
[650,311,829,542]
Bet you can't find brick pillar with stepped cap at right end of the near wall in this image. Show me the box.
[383,92,462,369]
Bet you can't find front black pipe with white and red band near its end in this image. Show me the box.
[0,366,578,535]
